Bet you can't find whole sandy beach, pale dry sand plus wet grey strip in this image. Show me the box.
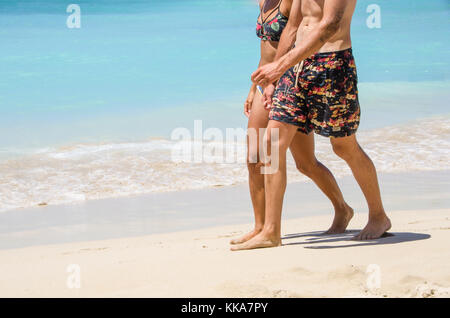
[0,171,450,297]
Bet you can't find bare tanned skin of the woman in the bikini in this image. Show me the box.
[230,0,353,244]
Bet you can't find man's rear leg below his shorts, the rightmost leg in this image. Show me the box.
[331,134,391,240]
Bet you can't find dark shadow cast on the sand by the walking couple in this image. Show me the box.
[282,230,431,249]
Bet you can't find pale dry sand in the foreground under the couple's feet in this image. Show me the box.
[0,209,450,297]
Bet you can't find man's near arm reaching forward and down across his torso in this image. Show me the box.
[252,0,348,86]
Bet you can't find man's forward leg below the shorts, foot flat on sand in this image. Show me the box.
[231,120,297,251]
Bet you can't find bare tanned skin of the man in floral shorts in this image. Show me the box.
[233,0,391,250]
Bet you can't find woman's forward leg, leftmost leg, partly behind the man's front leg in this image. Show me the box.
[230,92,269,244]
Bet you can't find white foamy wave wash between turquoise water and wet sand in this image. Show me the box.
[0,116,450,211]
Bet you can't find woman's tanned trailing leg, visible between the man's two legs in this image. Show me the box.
[289,132,353,234]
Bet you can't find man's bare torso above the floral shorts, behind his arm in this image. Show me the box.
[295,0,356,52]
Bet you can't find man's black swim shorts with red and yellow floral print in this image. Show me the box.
[269,48,360,137]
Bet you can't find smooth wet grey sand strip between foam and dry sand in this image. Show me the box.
[0,170,450,250]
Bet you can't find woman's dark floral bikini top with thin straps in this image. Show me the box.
[256,0,288,42]
